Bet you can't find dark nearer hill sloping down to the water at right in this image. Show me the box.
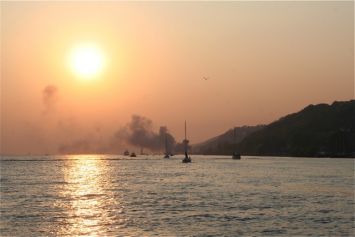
[197,100,355,157]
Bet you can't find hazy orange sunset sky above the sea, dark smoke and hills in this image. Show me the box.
[0,1,354,154]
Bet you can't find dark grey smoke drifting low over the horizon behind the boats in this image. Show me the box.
[58,115,176,154]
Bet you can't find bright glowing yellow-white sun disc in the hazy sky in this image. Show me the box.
[69,43,105,79]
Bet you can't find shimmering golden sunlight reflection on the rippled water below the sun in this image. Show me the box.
[59,155,119,236]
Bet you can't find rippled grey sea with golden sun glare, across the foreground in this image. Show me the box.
[0,155,354,236]
